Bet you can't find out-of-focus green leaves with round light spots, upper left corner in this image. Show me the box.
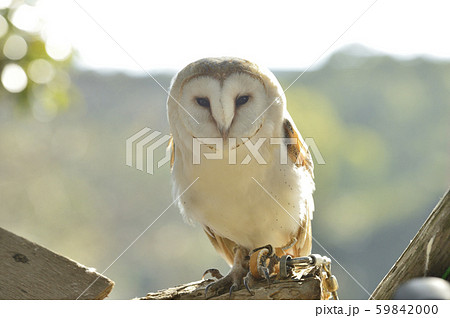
[0,0,75,121]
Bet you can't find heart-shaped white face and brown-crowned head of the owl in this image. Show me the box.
[168,58,285,149]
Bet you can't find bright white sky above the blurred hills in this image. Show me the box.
[33,0,450,72]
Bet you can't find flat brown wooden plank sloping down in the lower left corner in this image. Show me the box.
[0,228,114,299]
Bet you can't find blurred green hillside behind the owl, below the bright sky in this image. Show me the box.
[0,46,450,299]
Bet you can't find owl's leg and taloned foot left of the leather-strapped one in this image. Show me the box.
[205,246,249,299]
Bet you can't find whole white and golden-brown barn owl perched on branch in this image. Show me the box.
[167,57,315,294]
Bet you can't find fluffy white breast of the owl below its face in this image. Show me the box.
[173,140,312,249]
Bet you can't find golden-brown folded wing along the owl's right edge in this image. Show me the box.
[283,118,314,257]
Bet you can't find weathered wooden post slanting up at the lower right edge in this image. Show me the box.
[370,189,450,299]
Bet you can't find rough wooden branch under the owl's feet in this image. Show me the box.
[138,275,329,300]
